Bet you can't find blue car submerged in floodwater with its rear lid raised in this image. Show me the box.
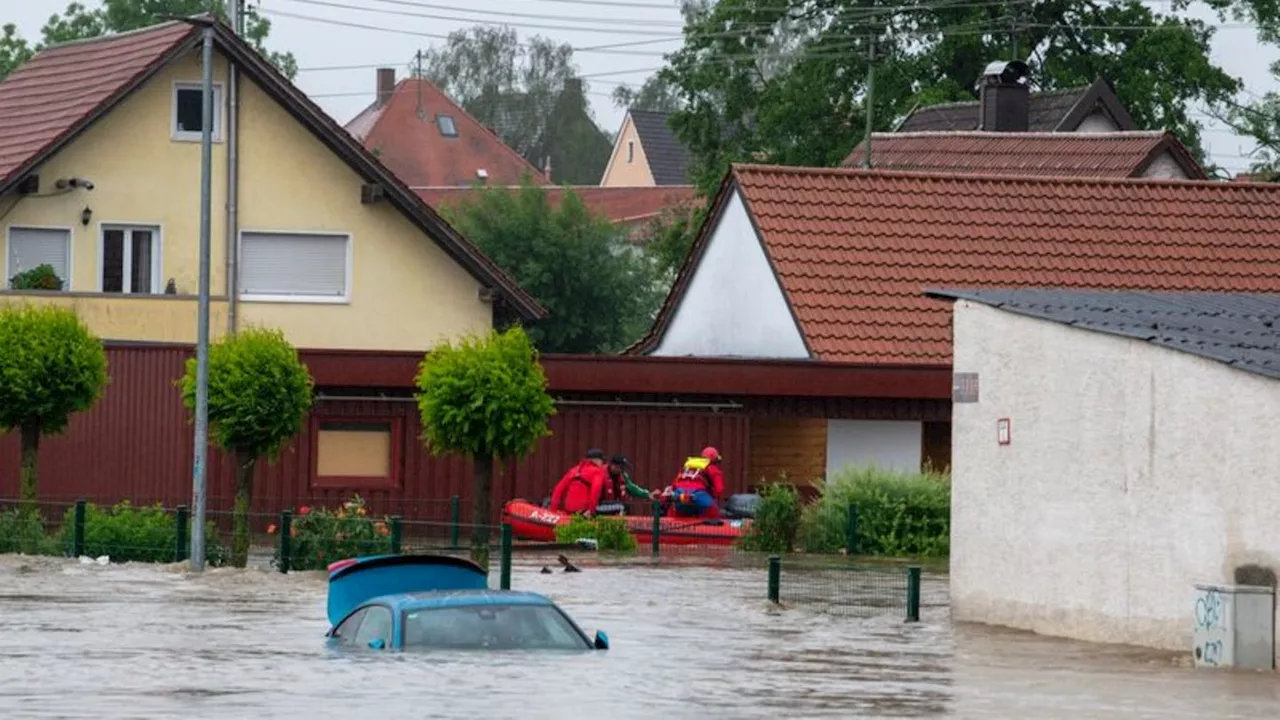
[326,555,609,651]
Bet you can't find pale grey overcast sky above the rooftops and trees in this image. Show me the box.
[0,0,1280,170]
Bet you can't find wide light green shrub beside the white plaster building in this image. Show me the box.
[800,468,951,557]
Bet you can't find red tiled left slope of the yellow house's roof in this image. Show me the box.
[0,22,198,188]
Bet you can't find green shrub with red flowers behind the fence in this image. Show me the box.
[277,495,392,570]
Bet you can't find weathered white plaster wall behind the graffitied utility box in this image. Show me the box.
[951,302,1280,652]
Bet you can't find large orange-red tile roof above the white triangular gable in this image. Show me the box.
[630,165,1280,364]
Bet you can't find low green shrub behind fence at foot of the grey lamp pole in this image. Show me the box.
[56,501,228,566]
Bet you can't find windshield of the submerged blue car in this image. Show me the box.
[404,605,589,650]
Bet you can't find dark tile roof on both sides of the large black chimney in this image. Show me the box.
[893,78,1137,132]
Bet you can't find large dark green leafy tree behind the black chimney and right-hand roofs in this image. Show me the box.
[660,0,1244,191]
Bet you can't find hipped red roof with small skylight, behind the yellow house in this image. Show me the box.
[347,78,548,187]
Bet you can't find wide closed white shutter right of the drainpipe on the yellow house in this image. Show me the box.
[241,233,349,297]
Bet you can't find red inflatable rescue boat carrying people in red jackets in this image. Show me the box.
[502,500,751,546]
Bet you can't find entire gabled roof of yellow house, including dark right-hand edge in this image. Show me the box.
[0,14,547,319]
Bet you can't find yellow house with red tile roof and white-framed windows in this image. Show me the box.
[0,17,545,351]
